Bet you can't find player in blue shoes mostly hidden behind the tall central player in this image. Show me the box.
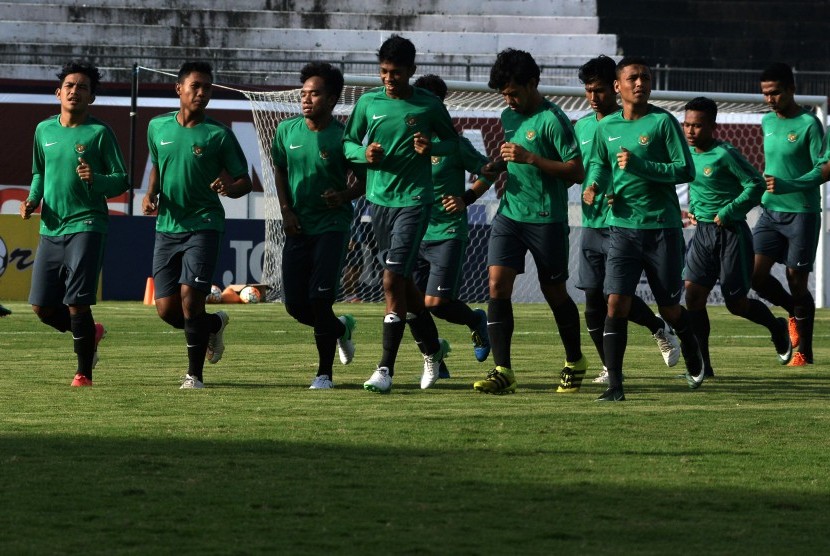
[415,75,492,368]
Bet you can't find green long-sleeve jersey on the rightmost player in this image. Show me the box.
[761,110,824,212]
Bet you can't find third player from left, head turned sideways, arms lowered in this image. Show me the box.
[271,63,363,390]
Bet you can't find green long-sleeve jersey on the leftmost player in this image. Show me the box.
[28,116,129,236]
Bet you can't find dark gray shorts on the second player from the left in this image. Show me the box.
[153,230,222,299]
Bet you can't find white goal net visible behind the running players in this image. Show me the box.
[243,77,826,304]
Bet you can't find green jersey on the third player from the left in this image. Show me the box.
[271,116,352,234]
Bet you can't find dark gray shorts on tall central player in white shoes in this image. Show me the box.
[372,205,432,277]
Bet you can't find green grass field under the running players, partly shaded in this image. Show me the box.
[0,302,830,555]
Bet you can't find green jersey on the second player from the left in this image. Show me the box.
[147,112,248,233]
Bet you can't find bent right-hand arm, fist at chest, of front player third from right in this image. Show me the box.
[617,116,695,185]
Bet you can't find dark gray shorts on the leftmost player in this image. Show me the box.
[29,232,107,307]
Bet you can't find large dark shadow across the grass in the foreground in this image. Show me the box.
[0,436,830,554]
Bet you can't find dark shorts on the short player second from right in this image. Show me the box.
[683,222,754,300]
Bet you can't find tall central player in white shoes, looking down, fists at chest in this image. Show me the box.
[343,35,458,393]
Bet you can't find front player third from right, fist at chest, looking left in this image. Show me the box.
[588,57,704,402]
